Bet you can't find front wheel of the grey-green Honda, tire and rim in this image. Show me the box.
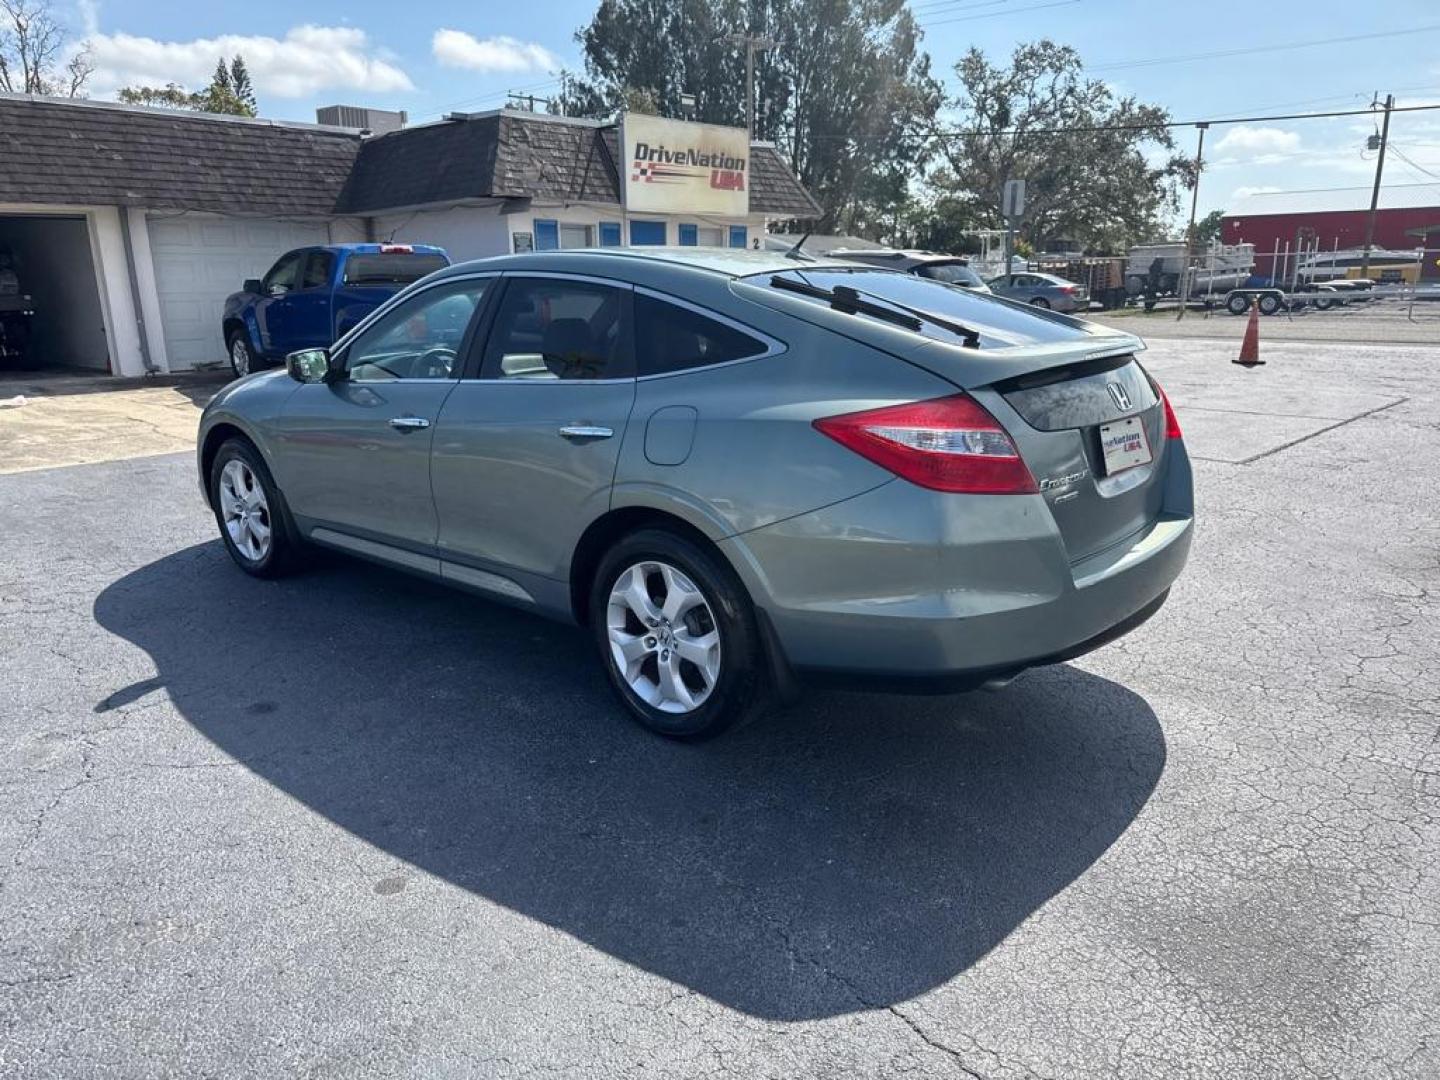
[209,439,304,577]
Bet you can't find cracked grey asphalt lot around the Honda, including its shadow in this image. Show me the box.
[0,340,1440,1080]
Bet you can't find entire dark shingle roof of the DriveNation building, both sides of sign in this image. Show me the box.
[0,94,819,217]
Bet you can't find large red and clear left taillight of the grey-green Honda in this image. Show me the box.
[815,393,1038,495]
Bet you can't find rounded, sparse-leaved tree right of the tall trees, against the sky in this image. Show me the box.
[933,40,1195,249]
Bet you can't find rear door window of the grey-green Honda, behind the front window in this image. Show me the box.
[481,278,629,379]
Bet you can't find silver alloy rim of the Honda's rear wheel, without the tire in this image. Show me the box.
[605,560,720,713]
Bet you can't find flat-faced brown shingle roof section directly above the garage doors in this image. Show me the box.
[0,95,360,215]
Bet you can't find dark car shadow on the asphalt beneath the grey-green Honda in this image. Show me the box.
[95,543,1165,1020]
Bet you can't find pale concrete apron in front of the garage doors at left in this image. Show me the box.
[0,372,229,474]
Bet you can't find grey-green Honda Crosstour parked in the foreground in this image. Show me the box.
[199,249,1192,737]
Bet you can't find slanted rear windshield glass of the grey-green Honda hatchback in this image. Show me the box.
[746,266,1086,348]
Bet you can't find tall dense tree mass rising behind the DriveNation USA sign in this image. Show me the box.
[555,0,939,233]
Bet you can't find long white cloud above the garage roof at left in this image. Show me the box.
[86,26,415,98]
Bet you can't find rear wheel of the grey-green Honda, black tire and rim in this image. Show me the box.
[589,528,768,740]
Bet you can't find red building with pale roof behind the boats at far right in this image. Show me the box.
[1221,184,1440,279]
